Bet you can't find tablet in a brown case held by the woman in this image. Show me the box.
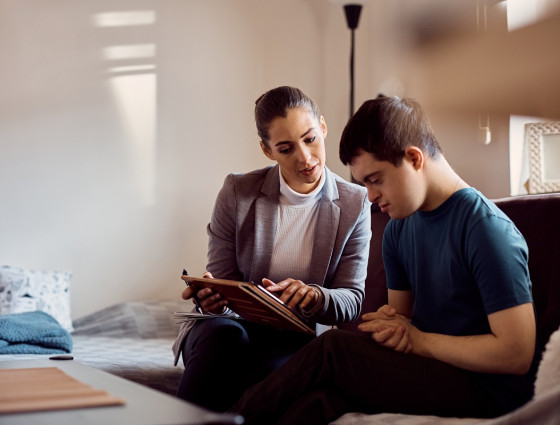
[181,275,315,335]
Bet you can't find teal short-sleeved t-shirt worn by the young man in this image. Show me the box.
[383,188,532,335]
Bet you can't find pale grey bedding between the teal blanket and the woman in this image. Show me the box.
[0,301,190,394]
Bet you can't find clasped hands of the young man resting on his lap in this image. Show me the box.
[358,305,413,353]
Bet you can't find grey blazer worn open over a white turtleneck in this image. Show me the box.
[173,165,371,362]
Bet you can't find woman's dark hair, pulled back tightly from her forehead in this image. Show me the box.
[255,86,321,146]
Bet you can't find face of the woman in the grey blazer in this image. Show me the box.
[261,108,327,193]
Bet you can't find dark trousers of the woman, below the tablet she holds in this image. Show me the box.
[177,318,314,411]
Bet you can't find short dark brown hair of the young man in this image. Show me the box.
[339,96,441,167]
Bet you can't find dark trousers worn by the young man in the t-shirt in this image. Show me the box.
[231,330,527,425]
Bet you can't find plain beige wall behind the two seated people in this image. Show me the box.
[0,0,544,317]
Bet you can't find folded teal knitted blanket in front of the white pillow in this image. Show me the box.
[0,311,72,354]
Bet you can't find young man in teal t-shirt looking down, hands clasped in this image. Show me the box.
[229,97,538,425]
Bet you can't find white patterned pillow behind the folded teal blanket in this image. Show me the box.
[0,266,73,332]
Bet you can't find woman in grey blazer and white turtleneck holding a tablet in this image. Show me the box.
[174,87,371,411]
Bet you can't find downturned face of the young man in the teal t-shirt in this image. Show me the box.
[350,150,424,219]
